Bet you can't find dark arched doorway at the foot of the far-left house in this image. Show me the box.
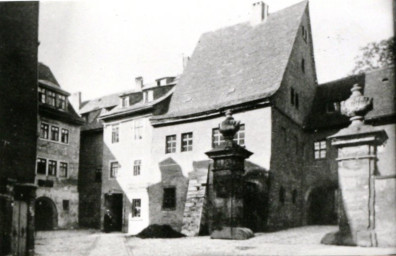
[34,197,58,230]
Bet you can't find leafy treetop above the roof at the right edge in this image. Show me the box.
[352,37,395,74]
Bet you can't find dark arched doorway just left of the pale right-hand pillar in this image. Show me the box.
[307,186,337,225]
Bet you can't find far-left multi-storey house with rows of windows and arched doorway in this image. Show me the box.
[35,63,83,230]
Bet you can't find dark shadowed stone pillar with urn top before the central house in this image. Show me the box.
[206,111,253,240]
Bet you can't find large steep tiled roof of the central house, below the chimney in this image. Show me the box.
[158,1,308,119]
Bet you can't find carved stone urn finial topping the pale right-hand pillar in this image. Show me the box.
[341,84,373,122]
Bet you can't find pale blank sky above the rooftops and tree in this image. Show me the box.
[39,0,393,100]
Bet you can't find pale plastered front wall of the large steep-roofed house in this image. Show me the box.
[150,107,272,230]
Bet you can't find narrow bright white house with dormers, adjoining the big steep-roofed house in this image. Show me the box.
[99,77,177,234]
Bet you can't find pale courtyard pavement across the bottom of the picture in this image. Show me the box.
[36,226,396,256]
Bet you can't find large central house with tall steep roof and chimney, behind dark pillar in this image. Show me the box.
[150,1,317,230]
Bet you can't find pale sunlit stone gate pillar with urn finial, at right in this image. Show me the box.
[329,84,388,247]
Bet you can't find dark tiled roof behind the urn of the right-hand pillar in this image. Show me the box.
[308,67,396,129]
